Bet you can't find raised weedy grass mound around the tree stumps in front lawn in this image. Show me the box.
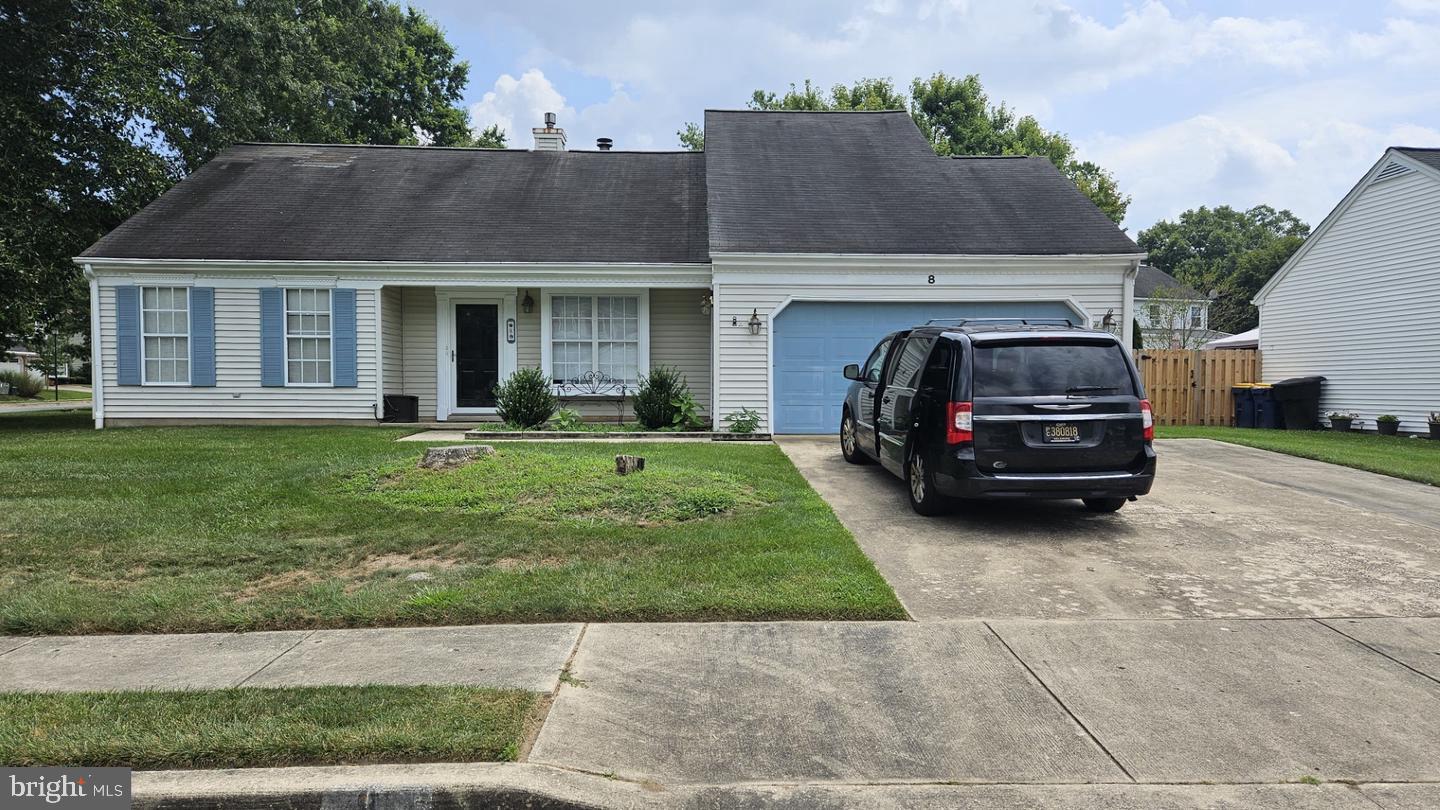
[347,444,766,526]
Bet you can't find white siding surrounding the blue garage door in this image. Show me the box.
[714,257,1129,431]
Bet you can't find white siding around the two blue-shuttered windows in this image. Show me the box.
[99,280,377,424]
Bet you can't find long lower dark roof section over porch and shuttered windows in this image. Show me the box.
[82,144,708,262]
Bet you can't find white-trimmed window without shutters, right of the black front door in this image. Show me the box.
[550,295,641,385]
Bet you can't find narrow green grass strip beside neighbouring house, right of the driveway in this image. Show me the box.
[1156,427,1440,486]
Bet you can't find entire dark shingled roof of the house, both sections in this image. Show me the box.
[90,111,1140,262]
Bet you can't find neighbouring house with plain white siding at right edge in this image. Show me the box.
[1254,147,1440,432]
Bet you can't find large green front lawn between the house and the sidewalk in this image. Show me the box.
[0,412,904,633]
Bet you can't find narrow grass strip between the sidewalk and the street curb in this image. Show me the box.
[0,686,537,770]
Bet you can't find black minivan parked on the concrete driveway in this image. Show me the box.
[840,319,1155,515]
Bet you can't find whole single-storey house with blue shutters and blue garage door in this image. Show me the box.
[75,111,1143,432]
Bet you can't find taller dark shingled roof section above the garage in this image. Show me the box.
[706,110,1142,255]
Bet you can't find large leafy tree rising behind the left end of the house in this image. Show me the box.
[0,0,484,344]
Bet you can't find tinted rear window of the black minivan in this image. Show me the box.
[973,340,1136,396]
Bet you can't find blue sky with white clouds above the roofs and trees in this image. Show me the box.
[410,0,1440,233]
